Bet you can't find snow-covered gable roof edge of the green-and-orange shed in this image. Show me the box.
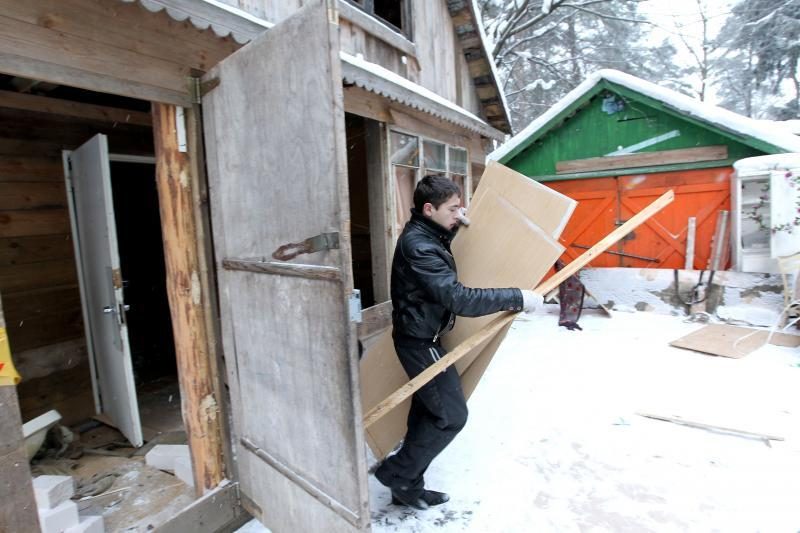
[487,70,800,161]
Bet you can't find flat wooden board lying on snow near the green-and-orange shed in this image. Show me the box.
[669,324,800,359]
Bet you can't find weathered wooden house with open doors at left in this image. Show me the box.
[0,0,510,532]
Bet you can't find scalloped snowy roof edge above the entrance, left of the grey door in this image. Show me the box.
[120,0,274,44]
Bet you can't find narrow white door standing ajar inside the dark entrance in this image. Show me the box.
[65,134,143,446]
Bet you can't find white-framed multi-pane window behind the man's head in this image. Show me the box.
[389,130,471,234]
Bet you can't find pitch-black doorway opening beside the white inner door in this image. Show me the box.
[111,160,178,386]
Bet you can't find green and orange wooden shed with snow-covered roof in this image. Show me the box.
[489,70,800,269]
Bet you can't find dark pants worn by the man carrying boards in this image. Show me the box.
[375,338,467,493]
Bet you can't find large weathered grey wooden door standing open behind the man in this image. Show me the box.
[202,0,369,533]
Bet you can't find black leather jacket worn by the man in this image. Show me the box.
[392,209,522,342]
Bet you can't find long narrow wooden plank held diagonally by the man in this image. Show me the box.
[364,190,675,427]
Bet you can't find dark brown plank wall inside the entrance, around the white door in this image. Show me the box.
[0,102,152,424]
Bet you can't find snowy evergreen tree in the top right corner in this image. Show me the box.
[718,0,800,120]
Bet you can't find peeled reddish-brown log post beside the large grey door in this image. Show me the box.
[153,103,224,495]
